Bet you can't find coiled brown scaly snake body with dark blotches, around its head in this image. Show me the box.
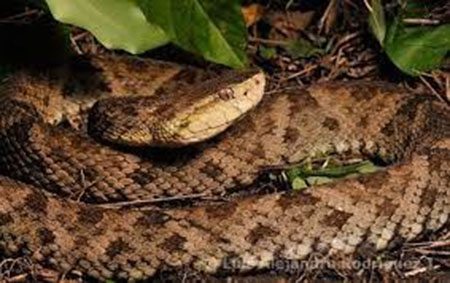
[0,54,450,280]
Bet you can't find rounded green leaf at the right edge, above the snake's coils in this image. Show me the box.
[384,20,450,76]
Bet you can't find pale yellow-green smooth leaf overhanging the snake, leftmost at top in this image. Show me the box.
[47,0,168,54]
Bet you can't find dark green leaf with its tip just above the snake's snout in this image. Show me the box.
[139,0,247,68]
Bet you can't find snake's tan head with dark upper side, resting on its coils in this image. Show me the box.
[89,70,265,147]
